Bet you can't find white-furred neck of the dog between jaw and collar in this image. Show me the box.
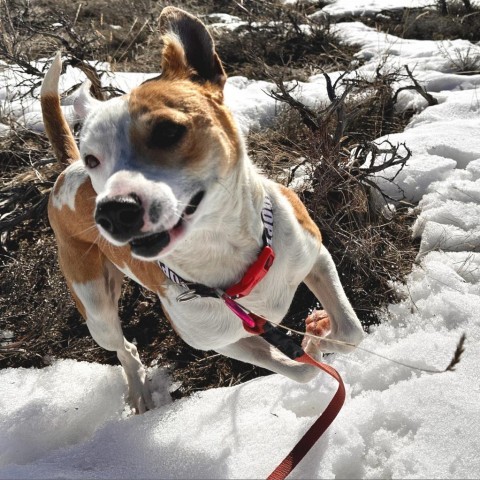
[162,148,266,288]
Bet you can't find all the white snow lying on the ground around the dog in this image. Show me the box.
[0,0,480,479]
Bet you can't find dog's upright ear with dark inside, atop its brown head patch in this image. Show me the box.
[160,7,227,89]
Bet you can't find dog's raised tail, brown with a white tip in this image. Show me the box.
[40,52,80,165]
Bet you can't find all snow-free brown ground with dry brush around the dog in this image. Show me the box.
[0,0,472,398]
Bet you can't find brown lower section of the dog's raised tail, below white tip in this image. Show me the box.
[41,93,80,165]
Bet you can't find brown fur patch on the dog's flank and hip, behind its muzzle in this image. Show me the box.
[48,173,165,300]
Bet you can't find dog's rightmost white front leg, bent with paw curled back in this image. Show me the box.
[304,245,364,353]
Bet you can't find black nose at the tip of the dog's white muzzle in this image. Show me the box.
[95,193,144,242]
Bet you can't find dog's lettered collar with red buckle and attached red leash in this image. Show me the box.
[158,195,345,480]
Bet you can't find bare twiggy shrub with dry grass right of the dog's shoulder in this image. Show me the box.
[250,68,416,326]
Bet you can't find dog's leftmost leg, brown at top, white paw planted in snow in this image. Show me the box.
[56,240,153,413]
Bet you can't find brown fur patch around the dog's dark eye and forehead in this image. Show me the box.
[129,78,240,172]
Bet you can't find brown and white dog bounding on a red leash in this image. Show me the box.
[41,7,363,412]
